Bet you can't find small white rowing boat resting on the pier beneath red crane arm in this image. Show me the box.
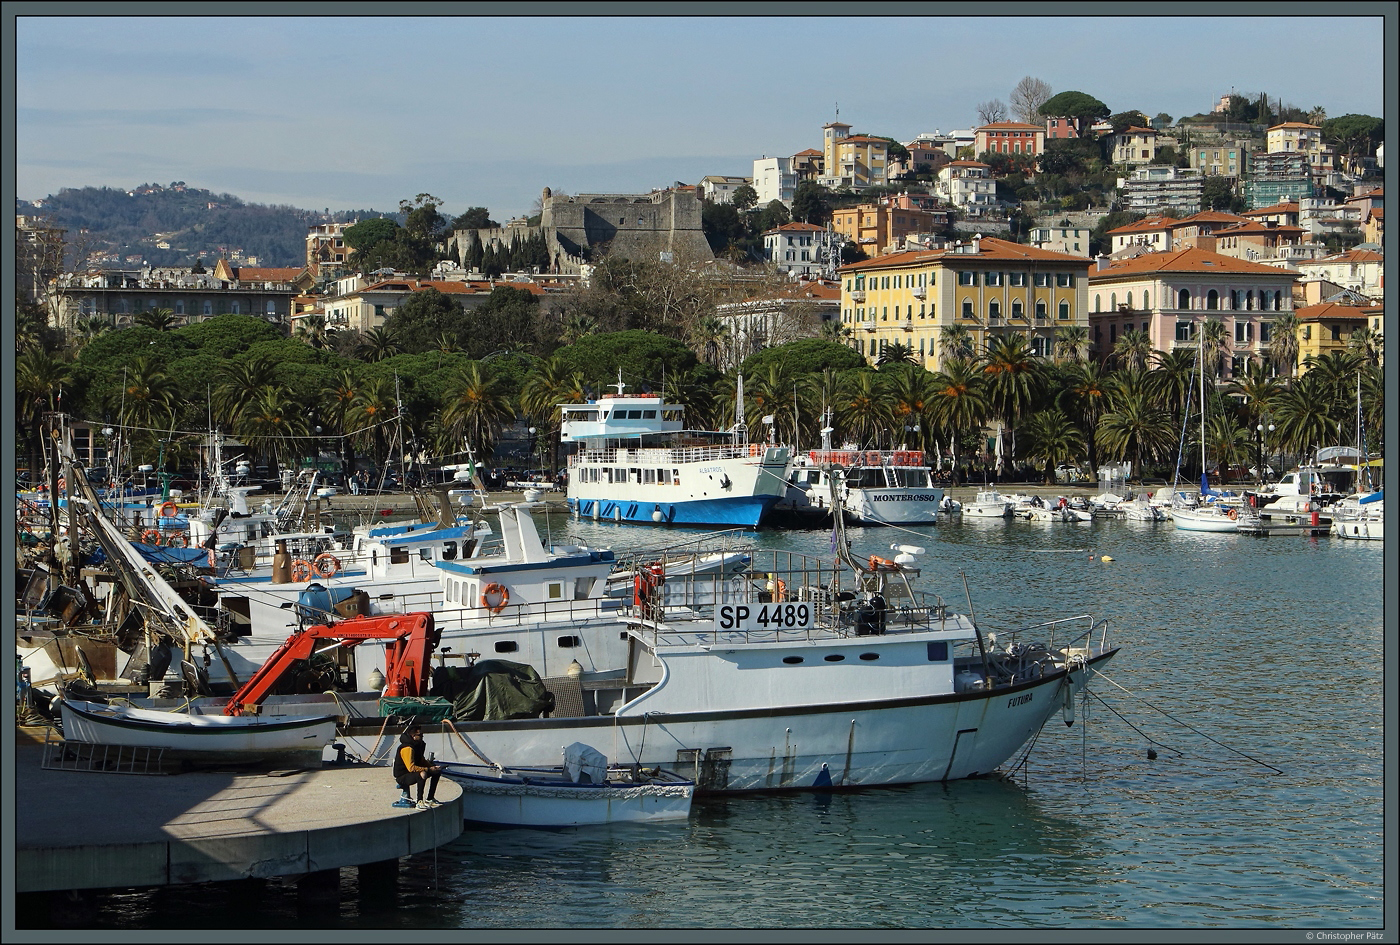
[59,699,336,755]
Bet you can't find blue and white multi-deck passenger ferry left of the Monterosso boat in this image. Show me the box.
[560,382,790,528]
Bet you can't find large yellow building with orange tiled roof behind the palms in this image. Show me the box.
[840,238,1091,371]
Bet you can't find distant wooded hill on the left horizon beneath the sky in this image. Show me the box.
[15,181,402,266]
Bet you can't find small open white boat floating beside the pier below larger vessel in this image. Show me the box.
[442,742,696,827]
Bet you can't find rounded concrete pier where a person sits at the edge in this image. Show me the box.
[13,741,462,893]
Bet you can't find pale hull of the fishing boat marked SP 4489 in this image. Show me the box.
[344,650,1117,794]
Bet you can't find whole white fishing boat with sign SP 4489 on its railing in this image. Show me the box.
[333,506,1117,792]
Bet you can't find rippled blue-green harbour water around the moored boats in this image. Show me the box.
[81,515,1385,930]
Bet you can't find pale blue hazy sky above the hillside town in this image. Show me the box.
[16,11,1389,223]
